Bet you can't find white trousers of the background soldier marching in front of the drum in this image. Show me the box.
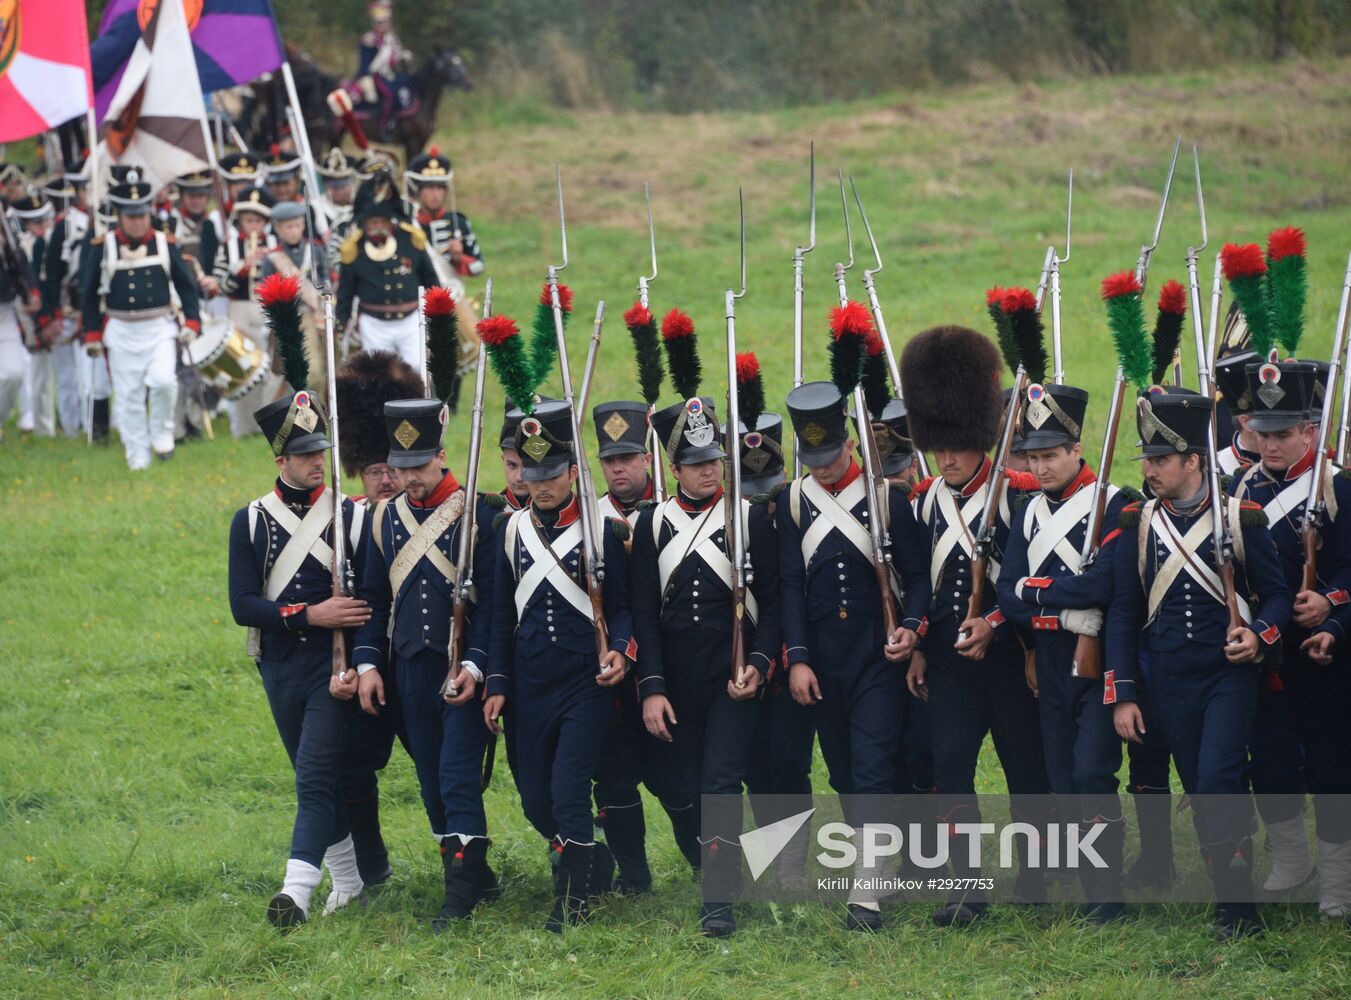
[103,316,178,469]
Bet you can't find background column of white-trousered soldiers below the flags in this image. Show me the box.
[0,147,484,469]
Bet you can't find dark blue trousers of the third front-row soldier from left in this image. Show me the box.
[511,647,613,843]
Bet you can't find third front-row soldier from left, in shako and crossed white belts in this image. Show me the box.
[484,403,638,932]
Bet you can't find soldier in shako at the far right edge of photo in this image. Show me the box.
[1231,361,1351,895]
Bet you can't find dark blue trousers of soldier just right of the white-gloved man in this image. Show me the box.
[1150,647,1258,849]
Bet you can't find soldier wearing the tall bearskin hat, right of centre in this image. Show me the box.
[901,327,1048,927]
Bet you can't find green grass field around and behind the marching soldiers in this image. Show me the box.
[0,62,1351,1000]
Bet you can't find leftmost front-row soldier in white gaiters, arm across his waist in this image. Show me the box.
[230,391,370,928]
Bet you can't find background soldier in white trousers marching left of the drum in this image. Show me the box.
[81,172,201,470]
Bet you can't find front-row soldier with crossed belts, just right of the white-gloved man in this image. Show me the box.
[1102,393,1292,936]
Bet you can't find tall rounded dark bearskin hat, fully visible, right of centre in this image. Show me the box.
[901,327,1004,451]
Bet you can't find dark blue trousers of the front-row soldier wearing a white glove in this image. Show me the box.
[1036,632,1121,819]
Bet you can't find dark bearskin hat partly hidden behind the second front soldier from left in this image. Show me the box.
[334,351,427,476]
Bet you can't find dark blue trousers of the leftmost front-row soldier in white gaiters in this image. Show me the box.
[258,642,361,868]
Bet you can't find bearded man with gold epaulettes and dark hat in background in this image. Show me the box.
[336,172,440,368]
